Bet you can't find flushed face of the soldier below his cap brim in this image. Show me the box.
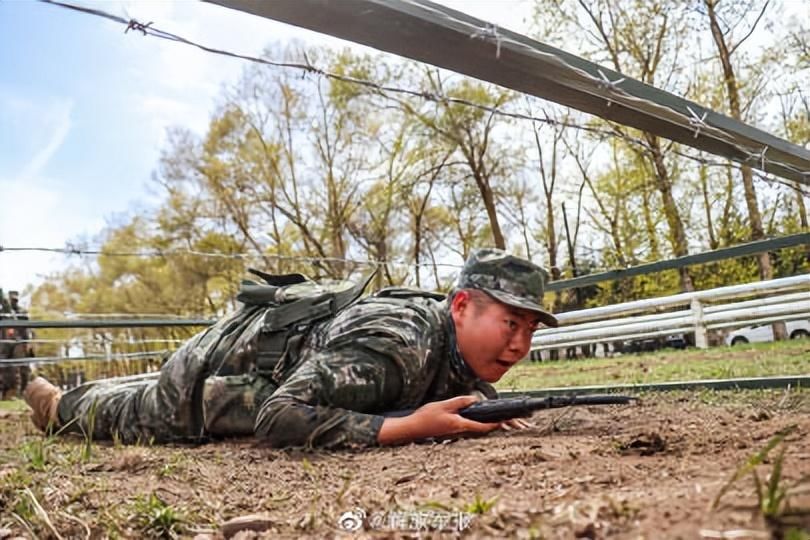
[451,291,538,382]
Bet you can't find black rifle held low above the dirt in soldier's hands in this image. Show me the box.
[383,394,638,423]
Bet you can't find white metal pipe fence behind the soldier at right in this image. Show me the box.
[532,274,810,358]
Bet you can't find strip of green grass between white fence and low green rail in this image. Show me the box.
[496,339,810,391]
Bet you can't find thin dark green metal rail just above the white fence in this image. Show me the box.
[546,233,810,291]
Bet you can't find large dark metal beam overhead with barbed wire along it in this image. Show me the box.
[205,0,810,185]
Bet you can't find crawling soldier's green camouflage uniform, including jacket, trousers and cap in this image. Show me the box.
[53,250,553,448]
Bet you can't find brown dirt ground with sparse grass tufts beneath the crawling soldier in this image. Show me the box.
[0,391,810,539]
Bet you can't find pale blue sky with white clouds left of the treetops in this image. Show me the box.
[0,0,528,296]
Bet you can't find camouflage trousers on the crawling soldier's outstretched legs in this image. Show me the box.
[58,306,276,444]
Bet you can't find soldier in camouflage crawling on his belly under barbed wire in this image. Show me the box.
[25,249,557,448]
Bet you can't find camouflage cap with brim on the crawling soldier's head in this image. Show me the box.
[457,248,557,327]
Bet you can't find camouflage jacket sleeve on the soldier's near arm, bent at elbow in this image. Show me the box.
[255,300,441,448]
